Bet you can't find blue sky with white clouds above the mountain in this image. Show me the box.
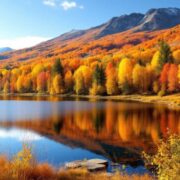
[0,0,180,49]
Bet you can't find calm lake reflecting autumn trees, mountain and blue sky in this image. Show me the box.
[0,96,180,174]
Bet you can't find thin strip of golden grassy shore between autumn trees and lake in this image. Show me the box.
[0,93,180,110]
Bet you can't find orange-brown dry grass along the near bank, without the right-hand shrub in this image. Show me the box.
[0,150,152,180]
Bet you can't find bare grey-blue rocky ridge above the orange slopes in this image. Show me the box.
[53,8,180,40]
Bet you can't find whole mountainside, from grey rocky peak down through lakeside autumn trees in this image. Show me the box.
[0,8,180,97]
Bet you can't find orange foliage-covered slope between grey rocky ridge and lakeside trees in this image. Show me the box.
[0,25,180,67]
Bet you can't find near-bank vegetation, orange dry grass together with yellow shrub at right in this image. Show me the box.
[0,135,180,180]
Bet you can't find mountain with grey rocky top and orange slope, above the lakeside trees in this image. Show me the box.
[0,8,180,64]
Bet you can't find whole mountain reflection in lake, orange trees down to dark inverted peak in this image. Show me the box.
[1,98,180,165]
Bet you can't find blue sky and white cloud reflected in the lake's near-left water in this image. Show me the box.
[0,128,104,167]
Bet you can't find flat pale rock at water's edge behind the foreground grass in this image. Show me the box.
[65,159,108,172]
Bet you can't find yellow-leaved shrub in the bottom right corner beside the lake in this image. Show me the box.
[143,135,180,180]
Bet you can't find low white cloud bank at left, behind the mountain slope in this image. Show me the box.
[0,36,50,49]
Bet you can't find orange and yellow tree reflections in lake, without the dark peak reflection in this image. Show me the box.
[2,101,180,153]
